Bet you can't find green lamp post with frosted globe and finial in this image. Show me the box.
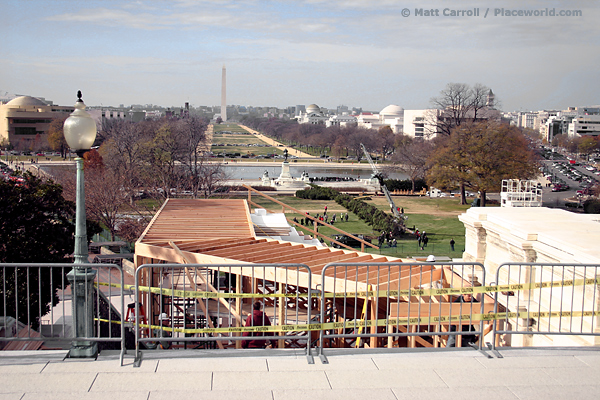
[63,91,98,358]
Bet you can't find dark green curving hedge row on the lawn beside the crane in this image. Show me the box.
[296,185,404,235]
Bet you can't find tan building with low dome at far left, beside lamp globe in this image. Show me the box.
[0,96,74,151]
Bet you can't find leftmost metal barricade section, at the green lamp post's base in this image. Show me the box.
[0,263,125,365]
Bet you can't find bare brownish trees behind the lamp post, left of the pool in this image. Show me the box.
[51,116,227,241]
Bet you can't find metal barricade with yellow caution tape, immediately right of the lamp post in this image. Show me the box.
[134,264,319,365]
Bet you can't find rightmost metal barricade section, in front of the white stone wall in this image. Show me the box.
[492,263,600,349]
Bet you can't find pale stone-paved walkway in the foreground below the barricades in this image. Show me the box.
[0,348,600,400]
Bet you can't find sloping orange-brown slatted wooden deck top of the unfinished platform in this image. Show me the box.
[136,199,401,290]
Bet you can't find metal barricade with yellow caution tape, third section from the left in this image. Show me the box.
[318,263,494,362]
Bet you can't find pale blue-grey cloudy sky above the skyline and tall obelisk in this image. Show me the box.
[0,0,600,111]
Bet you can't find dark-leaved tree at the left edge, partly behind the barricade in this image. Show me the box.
[0,174,75,329]
